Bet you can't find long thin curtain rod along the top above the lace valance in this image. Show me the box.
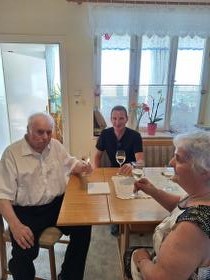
[66,0,210,6]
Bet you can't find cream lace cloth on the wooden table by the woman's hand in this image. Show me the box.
[112,176,151,199]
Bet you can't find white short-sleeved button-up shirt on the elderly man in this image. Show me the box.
[0,138,78,206]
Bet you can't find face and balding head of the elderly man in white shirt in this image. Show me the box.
[26,115,53,153]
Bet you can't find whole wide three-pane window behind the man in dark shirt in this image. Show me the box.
[96,34,206,132]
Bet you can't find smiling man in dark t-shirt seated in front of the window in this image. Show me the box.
[94,106,143,175]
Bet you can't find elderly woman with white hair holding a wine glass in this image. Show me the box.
[126,131,210,280]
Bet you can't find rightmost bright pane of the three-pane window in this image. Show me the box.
[170,37,205,131]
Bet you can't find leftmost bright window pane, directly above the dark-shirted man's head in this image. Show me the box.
[100,35,130,123]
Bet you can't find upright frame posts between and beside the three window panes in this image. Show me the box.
[94,35,210,131]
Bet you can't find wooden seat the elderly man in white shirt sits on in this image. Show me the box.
[0,215,62,280]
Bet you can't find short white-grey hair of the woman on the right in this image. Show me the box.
[173,131,210,172]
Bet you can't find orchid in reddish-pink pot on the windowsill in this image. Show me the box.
[147,90,164,135]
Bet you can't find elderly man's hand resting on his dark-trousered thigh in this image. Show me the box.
[10,223,34,249]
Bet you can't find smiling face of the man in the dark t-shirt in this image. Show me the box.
[111,110,128,133]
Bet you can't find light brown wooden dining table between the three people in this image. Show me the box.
[57,167,185,276]
